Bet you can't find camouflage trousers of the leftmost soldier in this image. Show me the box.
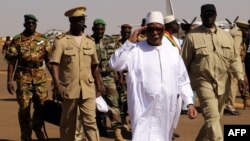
[16,81,48,141]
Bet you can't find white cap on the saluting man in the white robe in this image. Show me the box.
[146,11,164,25]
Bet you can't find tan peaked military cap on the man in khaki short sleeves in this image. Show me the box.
[64,6,86,18]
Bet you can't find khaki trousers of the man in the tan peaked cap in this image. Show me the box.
[60,98,99,141]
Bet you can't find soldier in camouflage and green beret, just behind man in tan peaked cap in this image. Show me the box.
[92,19,124,141]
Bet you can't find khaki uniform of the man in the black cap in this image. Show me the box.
[181,25,244,141]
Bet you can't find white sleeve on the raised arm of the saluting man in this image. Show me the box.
[109,40,135,71]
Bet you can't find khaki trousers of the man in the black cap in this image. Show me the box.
[195,87,225,141]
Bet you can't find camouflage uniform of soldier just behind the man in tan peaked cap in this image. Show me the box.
[96,35,123,128]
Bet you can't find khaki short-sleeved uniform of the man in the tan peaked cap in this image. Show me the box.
[50,32,99,141]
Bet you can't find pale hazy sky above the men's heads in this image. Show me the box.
[0,0,250,37]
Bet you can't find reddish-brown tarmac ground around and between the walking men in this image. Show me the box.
[0,50,250,141]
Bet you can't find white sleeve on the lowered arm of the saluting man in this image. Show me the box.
[178,57,194,106]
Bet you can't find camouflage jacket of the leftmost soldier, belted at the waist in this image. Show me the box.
[5,32,51,84]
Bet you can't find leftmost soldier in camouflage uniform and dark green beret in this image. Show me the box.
[5,14,50,141]
